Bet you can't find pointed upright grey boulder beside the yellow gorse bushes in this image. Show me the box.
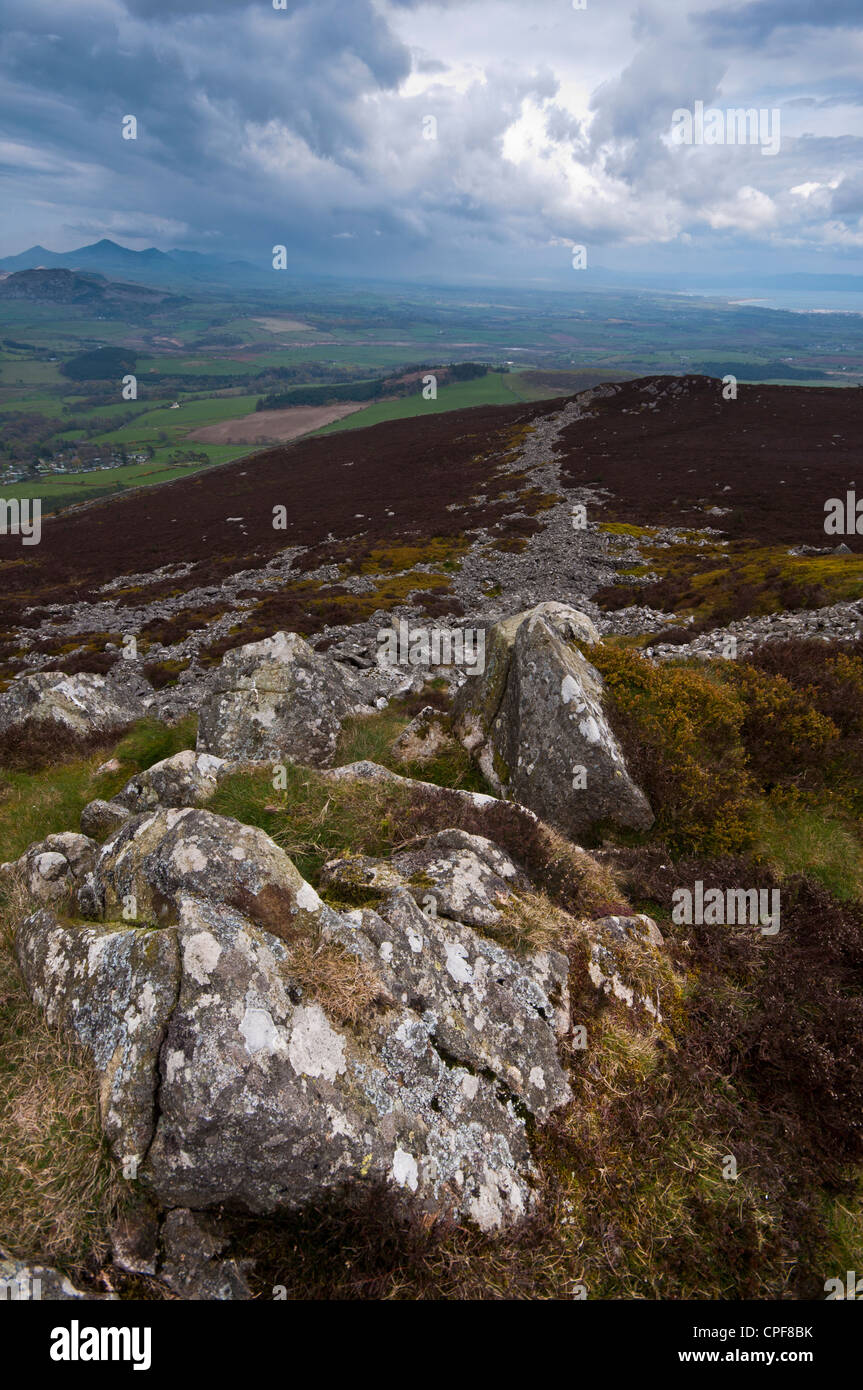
[453,605,653,838]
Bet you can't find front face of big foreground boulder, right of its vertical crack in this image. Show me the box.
[142,899,541,1229]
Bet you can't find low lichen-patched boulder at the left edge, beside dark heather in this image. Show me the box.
[0,662,154,734]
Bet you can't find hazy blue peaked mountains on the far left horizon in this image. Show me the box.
[0,236,270,285]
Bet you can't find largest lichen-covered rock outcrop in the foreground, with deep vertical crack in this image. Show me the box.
[15,808,568,1234]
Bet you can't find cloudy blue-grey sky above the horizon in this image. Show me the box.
[0,0,863,286]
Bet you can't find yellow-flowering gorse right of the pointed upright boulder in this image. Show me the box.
[591,642,863,878]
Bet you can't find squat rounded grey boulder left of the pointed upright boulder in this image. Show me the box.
[197,632,371,767]
